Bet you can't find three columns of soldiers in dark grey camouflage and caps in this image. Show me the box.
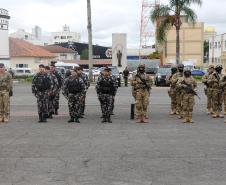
[32,63,121,123]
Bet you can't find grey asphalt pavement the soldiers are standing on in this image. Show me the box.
[0,83,226,185]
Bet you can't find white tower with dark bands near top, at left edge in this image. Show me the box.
[0,8,10,67]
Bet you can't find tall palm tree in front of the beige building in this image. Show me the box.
[151,0,202,64]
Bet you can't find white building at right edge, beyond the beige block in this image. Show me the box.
[209,33,226,68]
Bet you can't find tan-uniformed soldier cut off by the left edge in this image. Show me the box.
[0,63,12,123]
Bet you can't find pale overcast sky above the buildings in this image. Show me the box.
[0,0,226,48]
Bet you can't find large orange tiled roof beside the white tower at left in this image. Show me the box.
[9,37,56,58]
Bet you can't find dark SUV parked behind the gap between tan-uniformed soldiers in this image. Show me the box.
[155,67,171,86]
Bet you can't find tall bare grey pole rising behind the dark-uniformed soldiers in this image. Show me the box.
[87,0,93,82]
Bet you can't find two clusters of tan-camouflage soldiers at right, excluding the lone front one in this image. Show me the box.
[169,64,226,123]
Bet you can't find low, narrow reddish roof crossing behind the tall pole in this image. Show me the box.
[59,59,112,65]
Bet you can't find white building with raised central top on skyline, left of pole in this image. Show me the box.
[52,25,81,44]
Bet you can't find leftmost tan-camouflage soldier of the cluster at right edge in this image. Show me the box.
[202,65,214,114]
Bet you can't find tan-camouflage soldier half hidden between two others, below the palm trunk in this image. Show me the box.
[171,64,184,119]
